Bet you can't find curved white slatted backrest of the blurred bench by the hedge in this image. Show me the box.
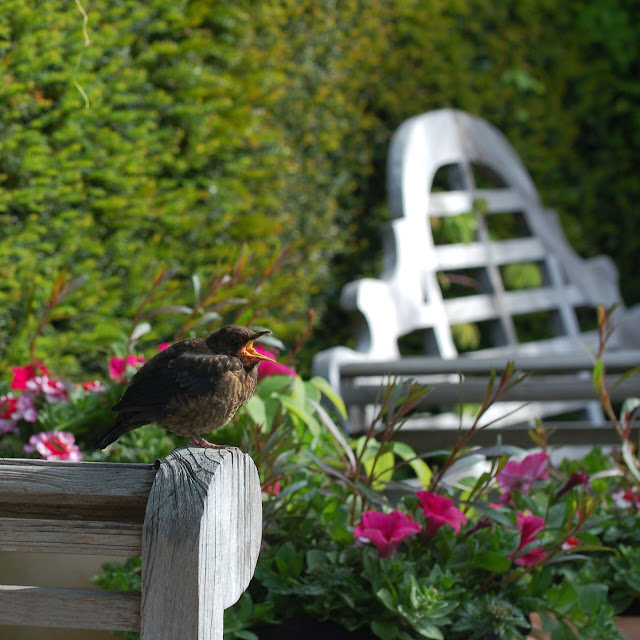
[313,109,640,436]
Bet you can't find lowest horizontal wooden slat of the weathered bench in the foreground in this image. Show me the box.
[0,585,140,631]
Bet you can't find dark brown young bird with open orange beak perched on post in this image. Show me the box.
[95,324,274,449]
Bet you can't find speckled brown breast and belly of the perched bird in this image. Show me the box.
[160,367,258,437]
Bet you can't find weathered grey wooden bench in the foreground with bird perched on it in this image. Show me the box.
[0,447,262,640]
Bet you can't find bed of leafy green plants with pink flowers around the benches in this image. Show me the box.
[0,278,640,640]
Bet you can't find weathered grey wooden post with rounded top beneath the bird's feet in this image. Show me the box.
[141,447,262,640]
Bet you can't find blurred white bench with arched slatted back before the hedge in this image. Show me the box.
[313,109,640,447]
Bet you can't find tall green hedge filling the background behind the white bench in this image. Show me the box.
[0,0,640,371]
